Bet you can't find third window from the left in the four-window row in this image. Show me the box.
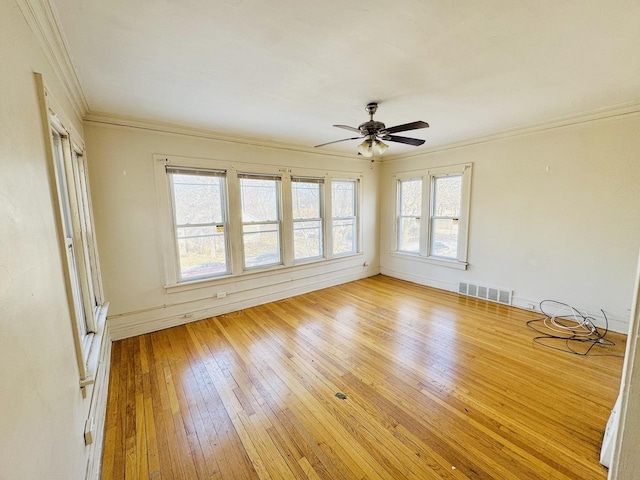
[291,177,324,260]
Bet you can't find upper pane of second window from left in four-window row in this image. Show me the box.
[240,178,279,223]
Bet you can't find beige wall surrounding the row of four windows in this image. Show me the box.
[85,121,379,338]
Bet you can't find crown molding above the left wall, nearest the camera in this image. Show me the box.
[16,0,89,122]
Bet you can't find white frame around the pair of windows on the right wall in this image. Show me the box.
[392,163,473,270]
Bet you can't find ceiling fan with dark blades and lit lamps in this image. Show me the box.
[315,102,429,157]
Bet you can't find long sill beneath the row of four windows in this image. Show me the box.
[164,253,364,293]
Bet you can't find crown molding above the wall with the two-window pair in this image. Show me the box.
[381,101,640,163]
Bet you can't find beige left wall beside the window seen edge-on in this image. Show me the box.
[0,1,100,480]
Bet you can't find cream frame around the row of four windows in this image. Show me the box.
[153,154,362,293]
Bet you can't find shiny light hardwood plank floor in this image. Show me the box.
[102,276,624,480]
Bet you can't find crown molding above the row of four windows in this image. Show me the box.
[84,112,370,163]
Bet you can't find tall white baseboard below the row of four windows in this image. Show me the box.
[107,266,380,340]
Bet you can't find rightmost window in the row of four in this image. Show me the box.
[331,180,358,255]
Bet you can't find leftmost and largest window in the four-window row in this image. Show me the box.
[167,167,229,281]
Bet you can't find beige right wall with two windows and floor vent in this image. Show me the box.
[380,114,640,333]
